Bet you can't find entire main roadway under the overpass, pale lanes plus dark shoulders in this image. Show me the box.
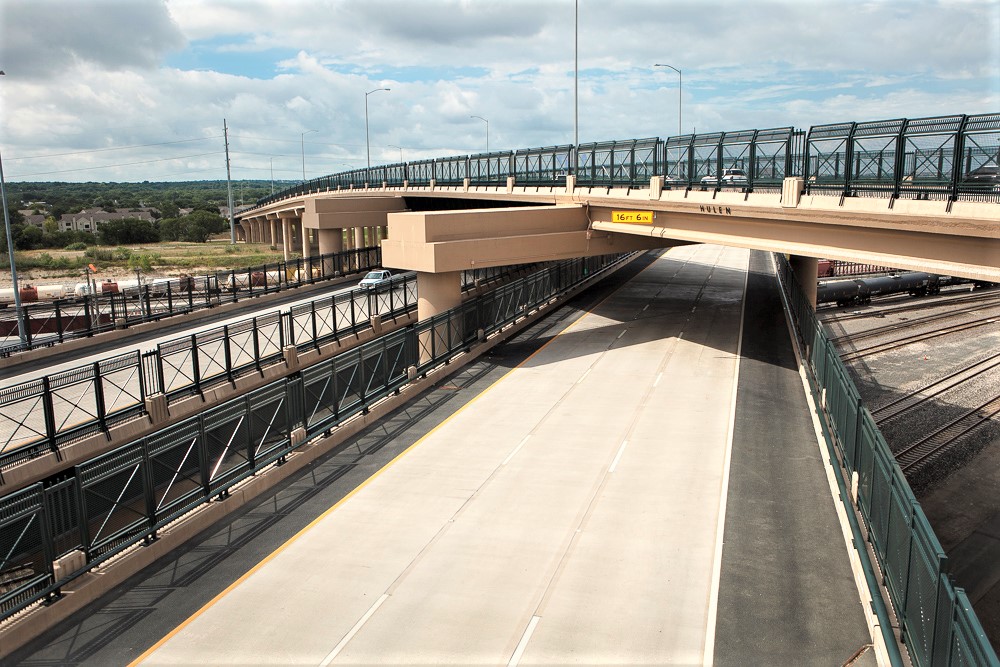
[5,246,874,664]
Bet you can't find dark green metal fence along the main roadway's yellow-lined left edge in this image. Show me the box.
[0,255,627,620]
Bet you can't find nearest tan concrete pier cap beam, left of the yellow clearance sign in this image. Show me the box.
[382,205,683,273]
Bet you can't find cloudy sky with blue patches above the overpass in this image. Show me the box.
[0,0,1000,181]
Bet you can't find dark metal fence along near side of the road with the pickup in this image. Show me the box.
[0,267,511,470]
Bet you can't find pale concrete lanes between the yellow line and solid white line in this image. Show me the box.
[137,246,747,664]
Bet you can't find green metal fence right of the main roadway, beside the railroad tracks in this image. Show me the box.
[776,255,1000,667]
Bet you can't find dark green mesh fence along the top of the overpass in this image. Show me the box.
[248,113,1000,213]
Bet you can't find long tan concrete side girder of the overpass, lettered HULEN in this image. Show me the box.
[236,183,1000,282]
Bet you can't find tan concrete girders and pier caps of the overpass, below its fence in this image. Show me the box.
[238,179,1000,282]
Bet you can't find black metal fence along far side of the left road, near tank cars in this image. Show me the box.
[0,247,382,356]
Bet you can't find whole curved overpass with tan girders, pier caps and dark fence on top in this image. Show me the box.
[239,114,1000,317]
